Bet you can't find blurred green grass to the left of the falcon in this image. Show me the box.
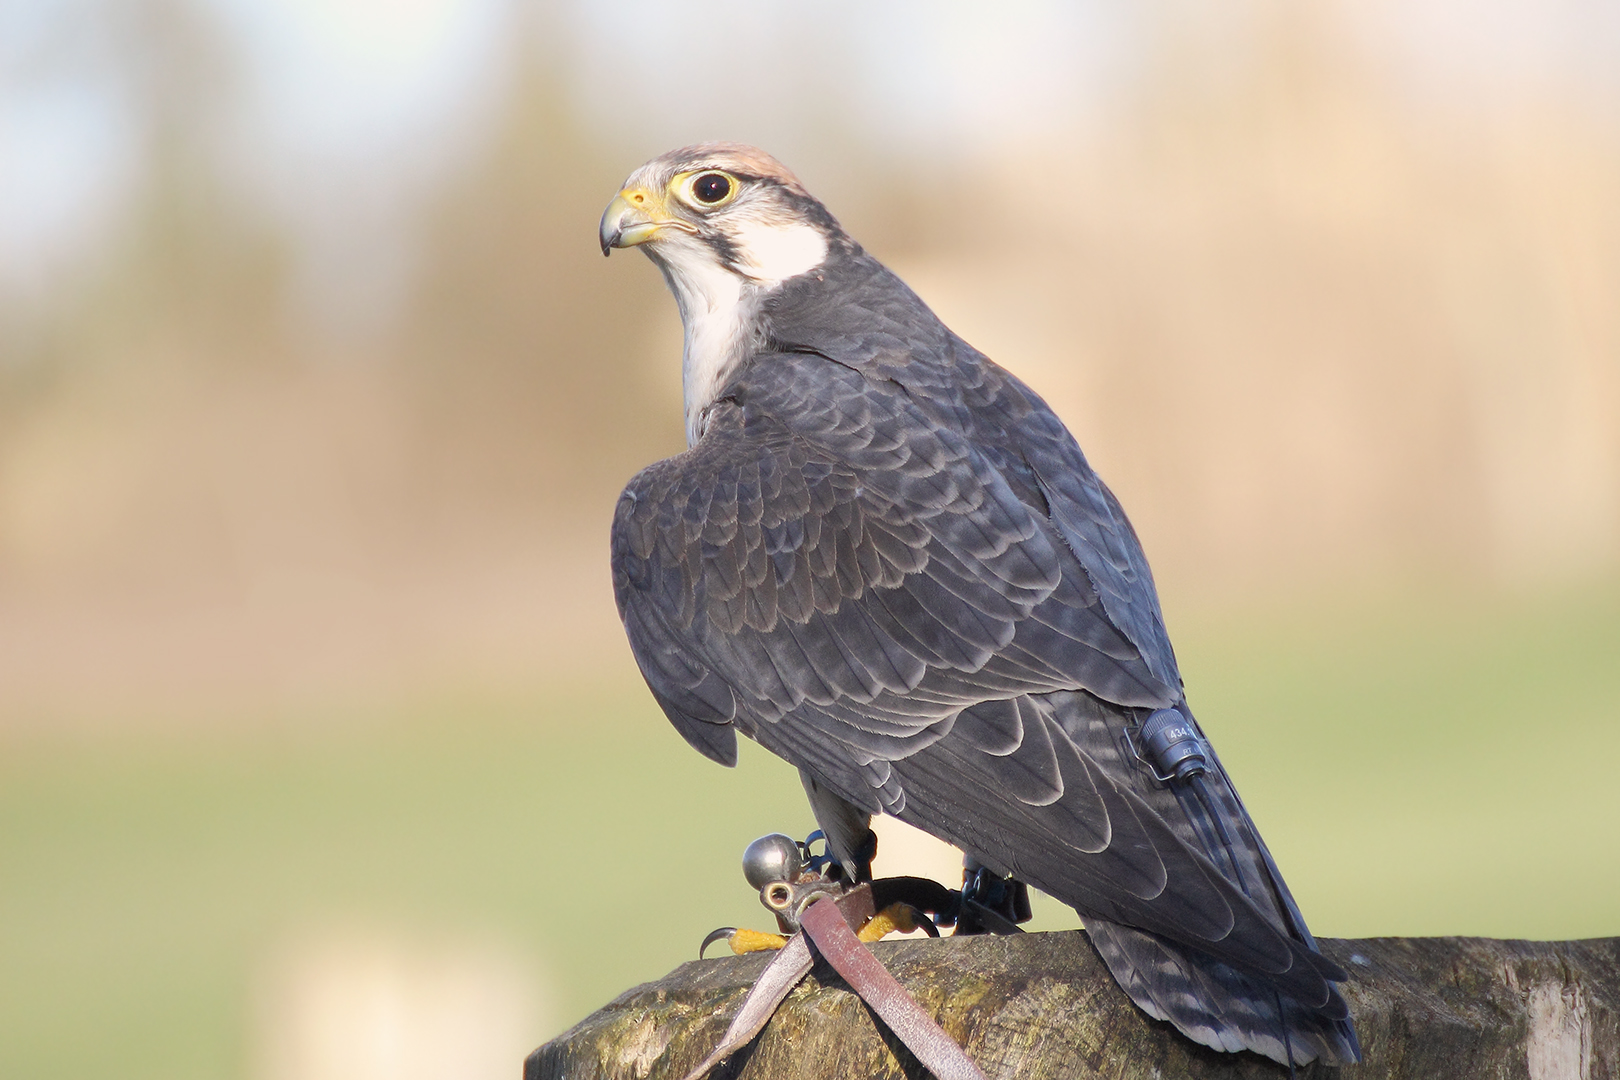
[0,674,813,1078]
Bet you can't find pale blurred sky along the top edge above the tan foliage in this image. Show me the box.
[0,0,1620,331]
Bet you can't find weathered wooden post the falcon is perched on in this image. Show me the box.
[523,931,1620,1080]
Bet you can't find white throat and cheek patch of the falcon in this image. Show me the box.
[658,222,826,447]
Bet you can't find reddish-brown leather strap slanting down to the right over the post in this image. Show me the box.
[799,900,987,1080]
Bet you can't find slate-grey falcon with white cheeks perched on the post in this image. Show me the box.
[601,142,1359,1065]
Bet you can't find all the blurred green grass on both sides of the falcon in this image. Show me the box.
[0,588,1620,1080]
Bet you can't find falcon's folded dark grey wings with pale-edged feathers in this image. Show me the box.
[614,355,1333,1007]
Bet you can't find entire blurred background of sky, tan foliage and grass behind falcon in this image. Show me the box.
[0,0,1620,1080]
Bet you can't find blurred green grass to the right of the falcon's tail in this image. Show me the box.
[1183,585,1620,939]
